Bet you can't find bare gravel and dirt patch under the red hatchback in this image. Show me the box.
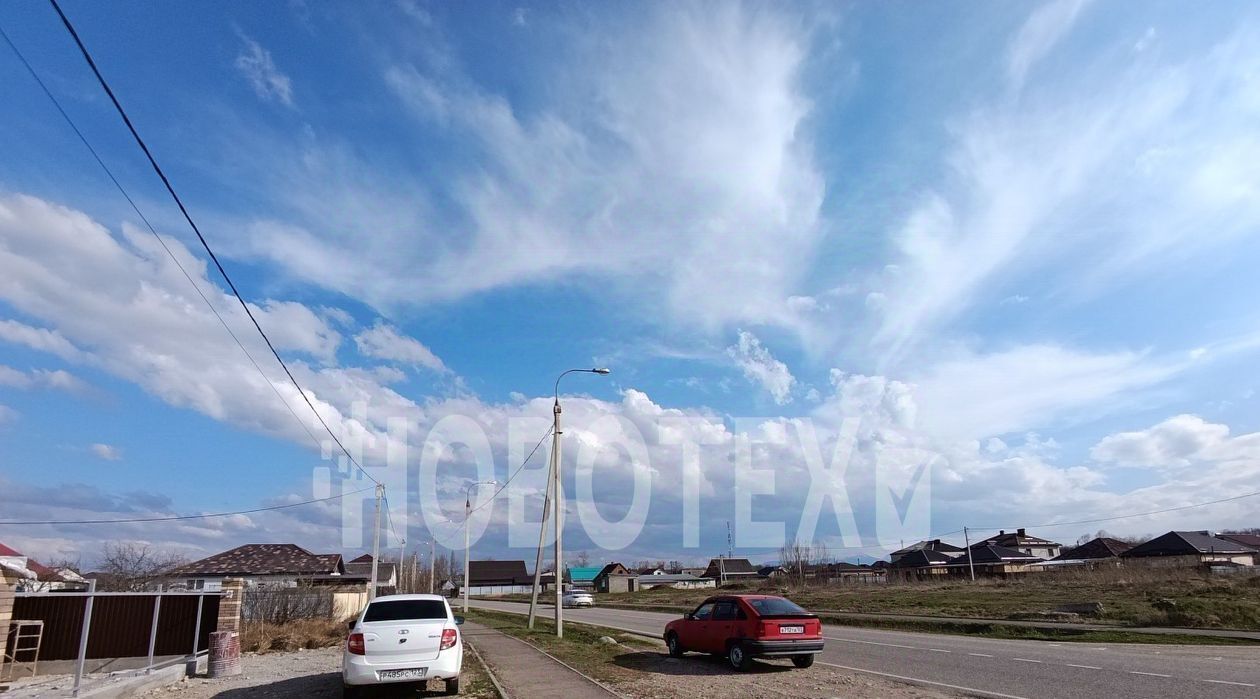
[614,651,959,699]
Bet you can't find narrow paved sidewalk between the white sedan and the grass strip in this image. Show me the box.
[462,621,619,699]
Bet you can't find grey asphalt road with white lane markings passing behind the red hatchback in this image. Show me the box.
[473,601,1260,699]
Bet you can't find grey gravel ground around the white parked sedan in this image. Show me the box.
[137,646,496,699]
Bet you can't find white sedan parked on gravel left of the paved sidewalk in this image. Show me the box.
[341,594,464,699]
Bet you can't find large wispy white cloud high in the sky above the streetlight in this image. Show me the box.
[234,5,824,331]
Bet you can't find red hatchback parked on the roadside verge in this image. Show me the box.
[664,594,823,670]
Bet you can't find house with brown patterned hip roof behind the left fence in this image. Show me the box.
[168,544,350,592]
